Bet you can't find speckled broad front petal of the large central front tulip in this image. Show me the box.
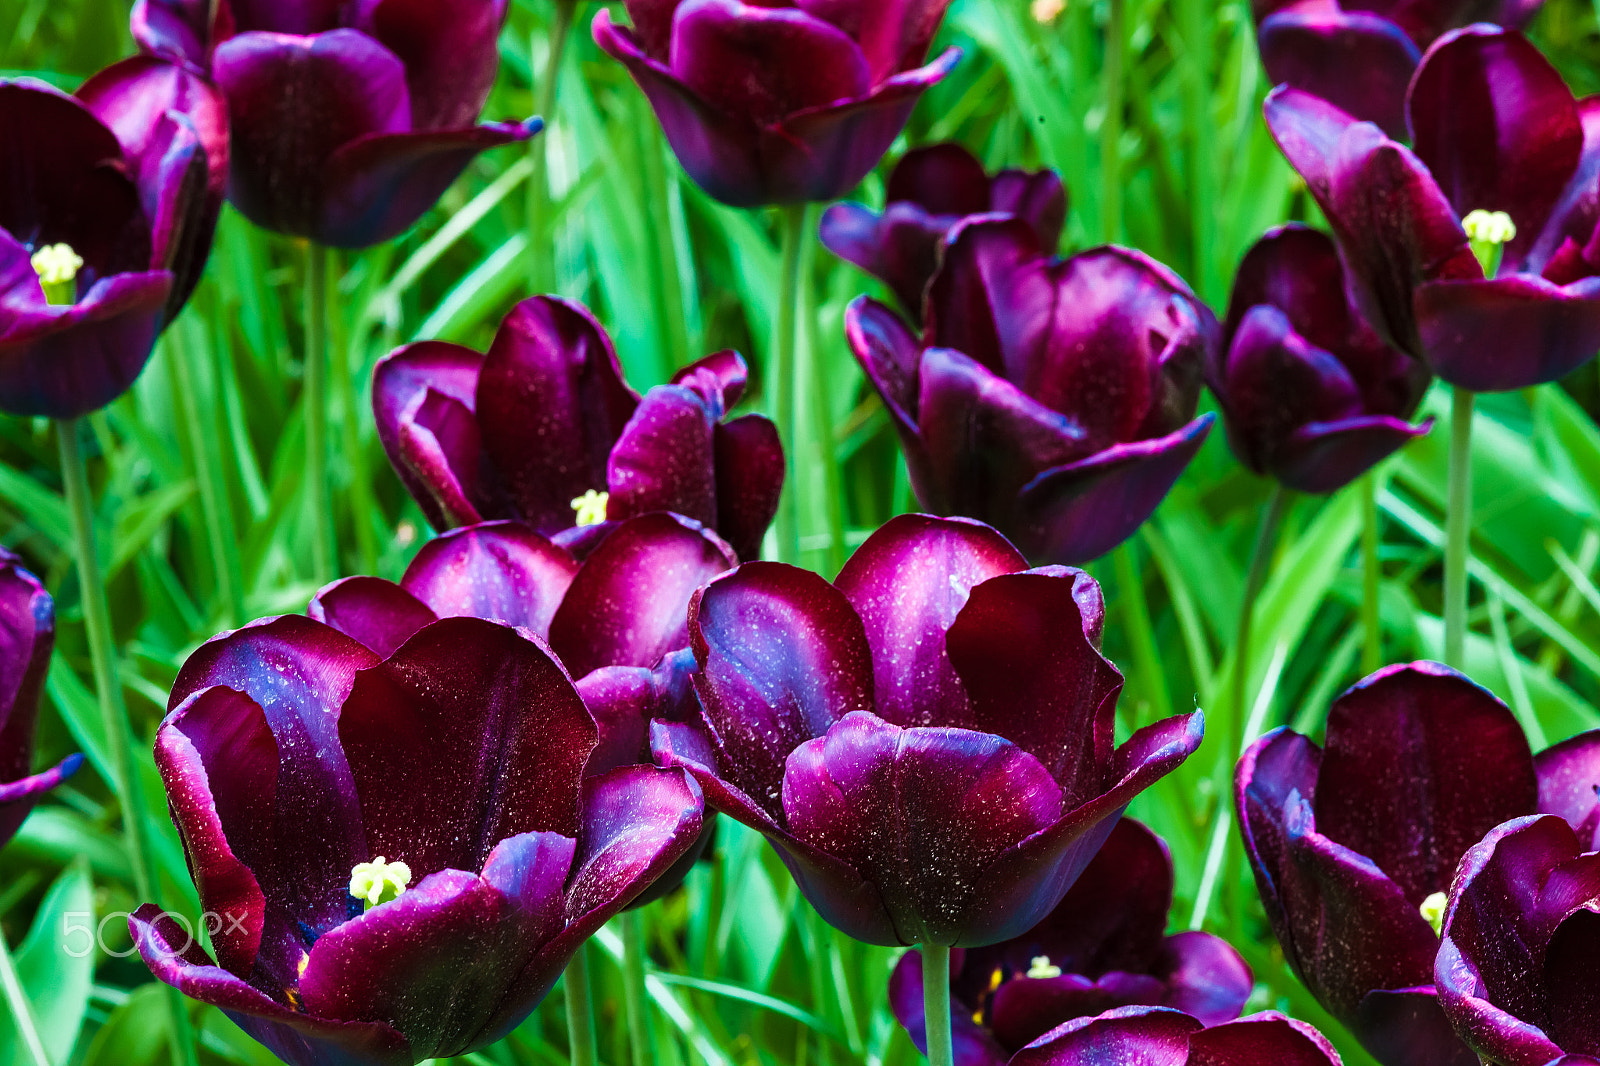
[782,712,1061,944]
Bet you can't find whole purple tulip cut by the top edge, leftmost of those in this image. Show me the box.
[133,0,541,248]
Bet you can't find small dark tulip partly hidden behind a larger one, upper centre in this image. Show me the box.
[821,142,1067,319]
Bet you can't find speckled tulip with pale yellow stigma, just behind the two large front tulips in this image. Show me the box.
[373,296,784,559]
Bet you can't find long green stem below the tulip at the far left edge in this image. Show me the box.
[56,418,195,1066]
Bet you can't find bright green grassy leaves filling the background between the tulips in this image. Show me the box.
[9,0,1600,1066]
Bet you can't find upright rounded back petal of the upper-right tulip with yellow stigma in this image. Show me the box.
[1406,24,1584,246]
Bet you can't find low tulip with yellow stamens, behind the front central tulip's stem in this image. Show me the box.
[890,818,1254,1066]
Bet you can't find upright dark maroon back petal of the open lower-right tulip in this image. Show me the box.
[1314,663,1538,902]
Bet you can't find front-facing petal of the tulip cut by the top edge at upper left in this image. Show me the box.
[211,29,411,238]
